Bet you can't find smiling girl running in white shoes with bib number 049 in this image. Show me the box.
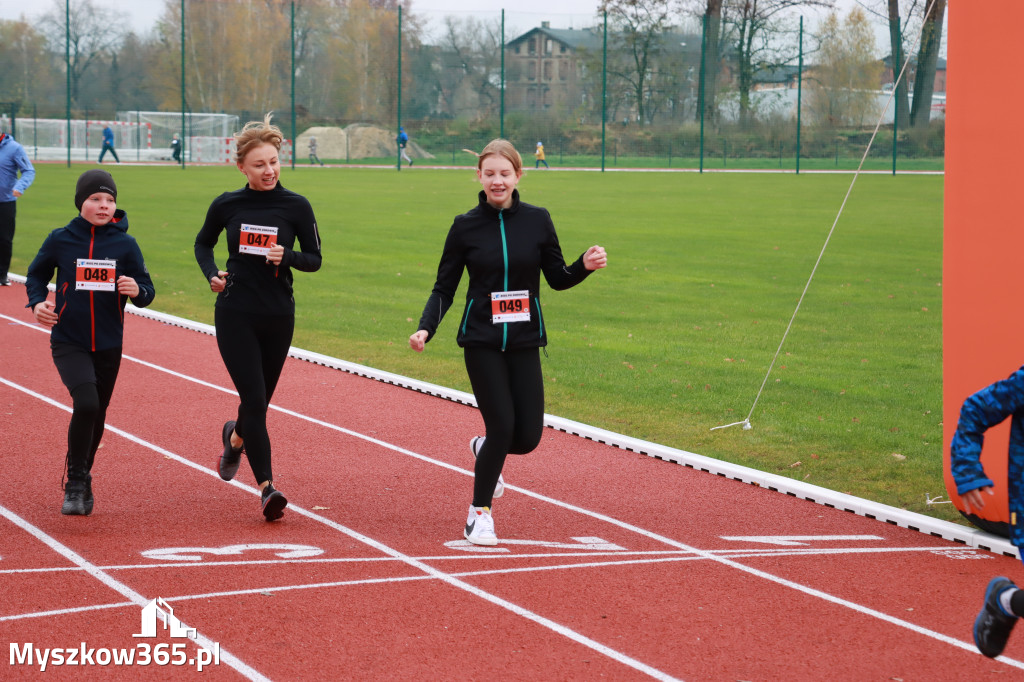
[409,139,607,545]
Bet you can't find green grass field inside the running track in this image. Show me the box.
[11,165,946,521]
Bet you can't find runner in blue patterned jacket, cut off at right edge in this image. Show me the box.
[949,368,1024,658]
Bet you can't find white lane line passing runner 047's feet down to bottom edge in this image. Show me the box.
[0,377,676,681]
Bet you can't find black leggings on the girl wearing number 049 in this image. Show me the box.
[464,348,544,507]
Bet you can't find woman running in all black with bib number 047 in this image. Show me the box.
[196,114,321,521]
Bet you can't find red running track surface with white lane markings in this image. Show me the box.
[0,285,1024,680]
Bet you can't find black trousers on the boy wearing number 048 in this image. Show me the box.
[50,343,121,482]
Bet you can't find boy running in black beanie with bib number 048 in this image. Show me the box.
[25,169,156,516]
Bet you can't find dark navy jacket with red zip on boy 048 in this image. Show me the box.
[25,209,156,351]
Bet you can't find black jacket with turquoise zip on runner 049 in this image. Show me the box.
[419,189,590,350]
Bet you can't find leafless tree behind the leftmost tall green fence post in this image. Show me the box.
[39,0,125,106]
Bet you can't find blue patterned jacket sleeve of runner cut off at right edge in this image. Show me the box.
[949,368,1024,495]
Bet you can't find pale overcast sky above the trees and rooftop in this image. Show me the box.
[0,0,929,56]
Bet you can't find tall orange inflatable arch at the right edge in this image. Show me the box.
[942,0,1024,536]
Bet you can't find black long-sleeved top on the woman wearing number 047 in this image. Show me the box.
[196,182,322,315]
